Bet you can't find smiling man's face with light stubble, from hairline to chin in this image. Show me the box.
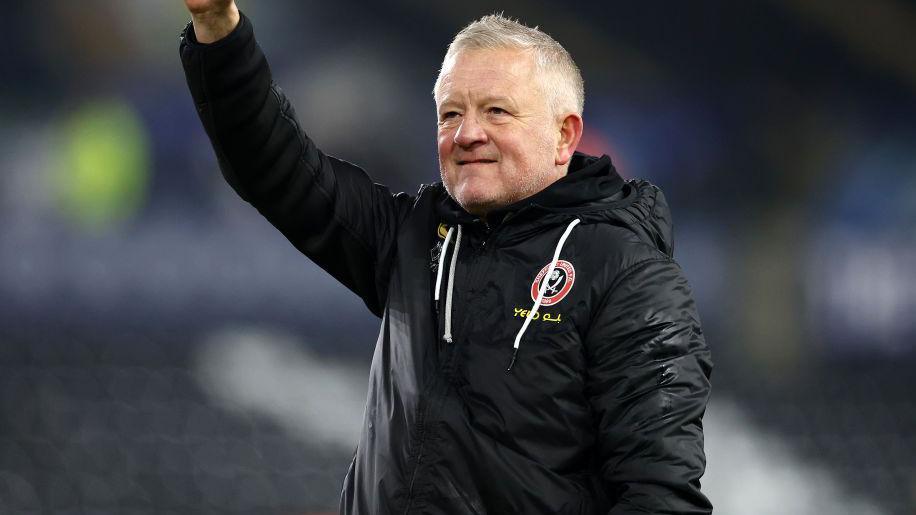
[436,49,563,215]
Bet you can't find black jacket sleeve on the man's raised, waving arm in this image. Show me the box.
[179,15,413,316]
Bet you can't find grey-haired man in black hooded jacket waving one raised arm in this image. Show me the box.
[180,0,712,515]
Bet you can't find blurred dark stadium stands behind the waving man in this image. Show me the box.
[0,0,916,515]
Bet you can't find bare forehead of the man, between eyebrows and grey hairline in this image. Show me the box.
[437,48,535,102]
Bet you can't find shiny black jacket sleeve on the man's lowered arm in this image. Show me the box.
[586,258,712,515]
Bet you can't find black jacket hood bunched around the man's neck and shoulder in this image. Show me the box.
[438,152,673,257]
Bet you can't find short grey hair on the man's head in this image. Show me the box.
[433,13,585,116]
